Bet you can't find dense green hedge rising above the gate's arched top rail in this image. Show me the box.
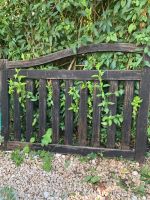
[0,0,150,61]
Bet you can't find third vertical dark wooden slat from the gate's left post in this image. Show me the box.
[38,79,47,139]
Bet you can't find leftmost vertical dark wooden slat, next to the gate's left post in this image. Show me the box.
[14,90,21,141]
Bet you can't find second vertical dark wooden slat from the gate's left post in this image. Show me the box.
[26,80,33,142]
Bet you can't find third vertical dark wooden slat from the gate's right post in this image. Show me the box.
[92,81,101,147]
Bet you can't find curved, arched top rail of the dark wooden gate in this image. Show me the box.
[8,43,143,68]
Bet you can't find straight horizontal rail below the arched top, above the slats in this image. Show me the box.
[8,70,142,81]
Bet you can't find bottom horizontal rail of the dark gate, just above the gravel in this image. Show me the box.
[7,141,135,158]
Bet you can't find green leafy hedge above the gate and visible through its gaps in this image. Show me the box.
[0,0,150,147]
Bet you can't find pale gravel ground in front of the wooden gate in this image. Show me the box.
[0,152,150,200]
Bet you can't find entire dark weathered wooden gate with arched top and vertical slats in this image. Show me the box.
[1,44,150,161]
